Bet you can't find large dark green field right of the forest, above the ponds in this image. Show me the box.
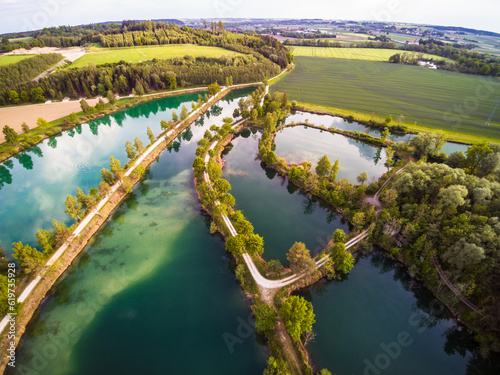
[272,57,500,142]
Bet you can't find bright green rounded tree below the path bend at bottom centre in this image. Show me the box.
[278,296,315,340]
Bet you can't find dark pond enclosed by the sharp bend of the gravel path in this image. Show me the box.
[223,131,348,264]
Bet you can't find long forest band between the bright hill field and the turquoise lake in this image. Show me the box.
[0,55,280,105]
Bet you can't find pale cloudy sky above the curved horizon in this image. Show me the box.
[0,0,500,33]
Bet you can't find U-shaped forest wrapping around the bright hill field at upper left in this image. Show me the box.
[0,21,293,105]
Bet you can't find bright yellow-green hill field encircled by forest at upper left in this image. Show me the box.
[68,44,244,68]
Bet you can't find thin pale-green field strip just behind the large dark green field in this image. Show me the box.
[292,46,452,61]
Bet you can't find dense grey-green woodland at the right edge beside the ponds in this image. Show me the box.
[375,134,500,352]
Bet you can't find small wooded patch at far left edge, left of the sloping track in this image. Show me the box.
[0,53,63,93]
